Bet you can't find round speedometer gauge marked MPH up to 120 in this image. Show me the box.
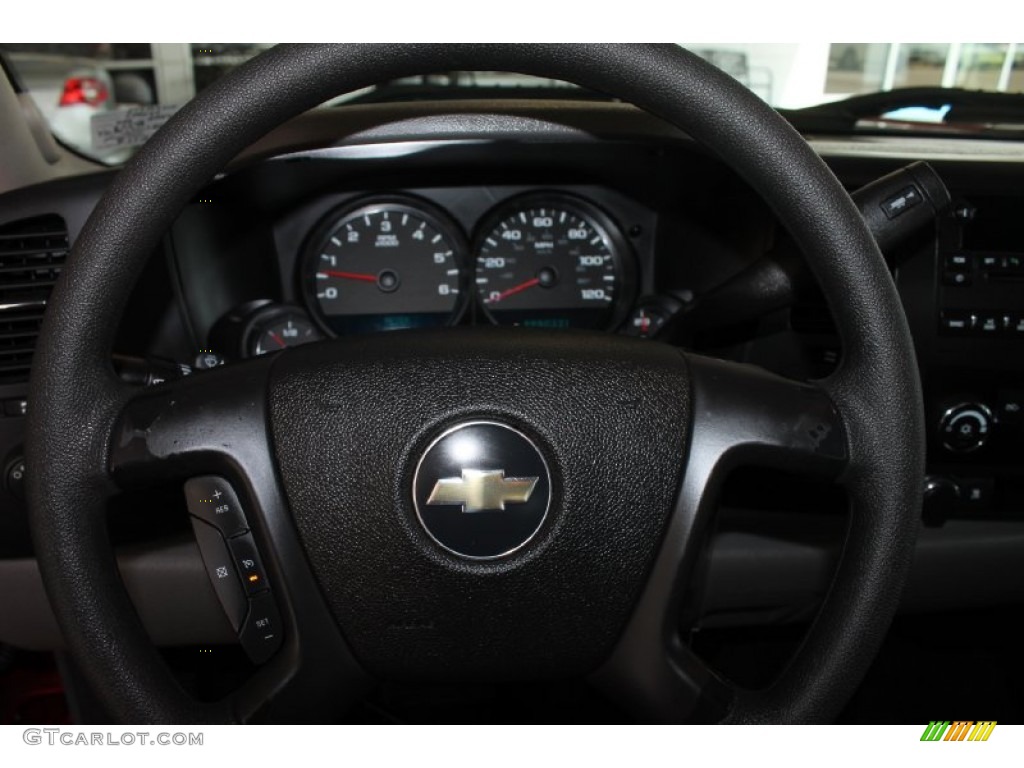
[474,196,630,329]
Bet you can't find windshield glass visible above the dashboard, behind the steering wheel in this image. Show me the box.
[0,43,1024,165]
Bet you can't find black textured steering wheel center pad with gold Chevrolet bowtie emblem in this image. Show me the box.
[270,329,689,679]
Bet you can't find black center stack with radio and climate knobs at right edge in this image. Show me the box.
[895,195,1024,523]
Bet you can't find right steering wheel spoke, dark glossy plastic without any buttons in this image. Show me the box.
[595,355,848,722]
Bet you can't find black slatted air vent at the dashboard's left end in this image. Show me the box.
[0,215,68,384]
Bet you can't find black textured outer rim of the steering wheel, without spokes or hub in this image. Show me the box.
[27,45,924,722]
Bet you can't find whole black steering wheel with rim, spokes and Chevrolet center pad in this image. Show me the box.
[27,45,924,723]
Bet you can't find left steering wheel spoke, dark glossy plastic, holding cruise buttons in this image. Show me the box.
[110,358,366,722]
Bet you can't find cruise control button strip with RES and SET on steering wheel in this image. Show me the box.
[184,475,283,664]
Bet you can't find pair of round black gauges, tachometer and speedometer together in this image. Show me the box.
[298,193,636,335]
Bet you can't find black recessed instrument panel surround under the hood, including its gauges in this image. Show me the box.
[163,132,770,366]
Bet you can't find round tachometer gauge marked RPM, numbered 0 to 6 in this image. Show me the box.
[302,199,465,334]
